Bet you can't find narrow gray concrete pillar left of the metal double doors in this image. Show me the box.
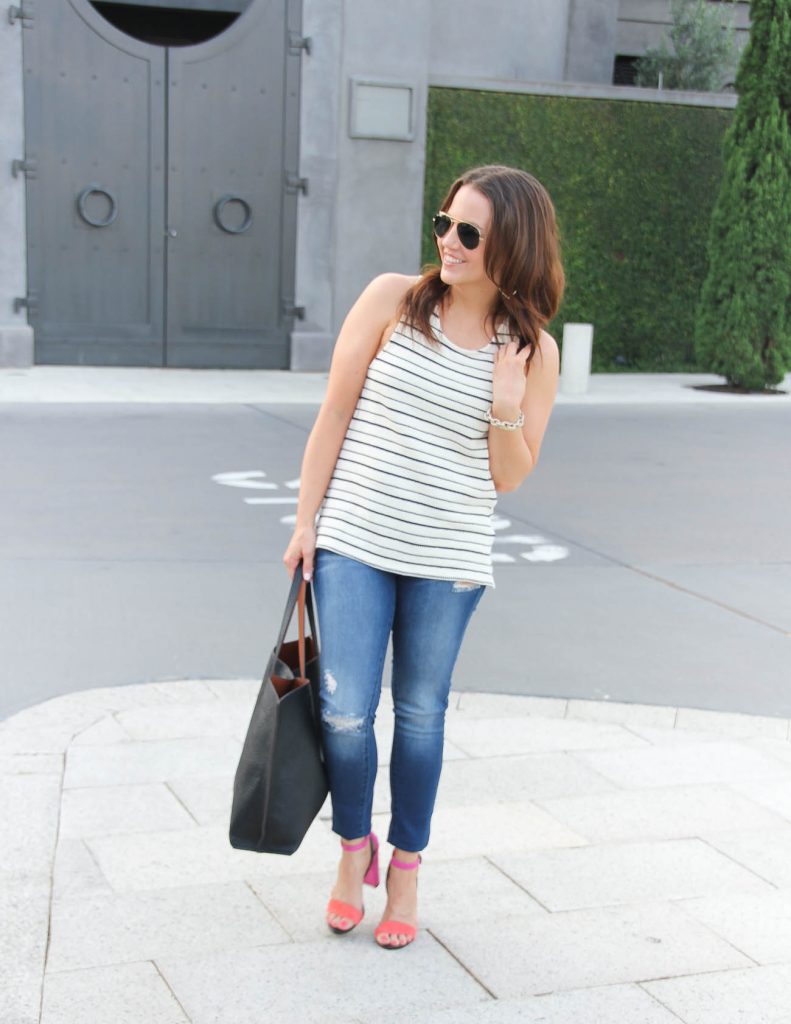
[0,12,33,367]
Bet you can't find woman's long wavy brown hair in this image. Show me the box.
[399,164,566,374]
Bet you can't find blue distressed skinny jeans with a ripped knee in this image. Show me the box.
[314,548,485,851]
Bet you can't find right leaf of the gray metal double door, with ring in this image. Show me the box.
[166,0,294,368]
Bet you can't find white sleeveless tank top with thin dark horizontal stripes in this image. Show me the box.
[316,301,509,588]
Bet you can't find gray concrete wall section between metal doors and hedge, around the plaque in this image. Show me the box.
[291,0,431,370]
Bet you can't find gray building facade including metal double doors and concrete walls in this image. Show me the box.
[0,0,749,370]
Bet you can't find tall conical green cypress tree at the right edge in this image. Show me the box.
[695,0,791,391]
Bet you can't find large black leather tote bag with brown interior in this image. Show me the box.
[228,562,328,854]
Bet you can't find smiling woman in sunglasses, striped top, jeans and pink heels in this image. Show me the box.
[283,165,565,949]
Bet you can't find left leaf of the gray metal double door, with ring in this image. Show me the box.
[24,0,165,366]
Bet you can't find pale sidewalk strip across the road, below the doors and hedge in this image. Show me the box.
[0,366,791,406]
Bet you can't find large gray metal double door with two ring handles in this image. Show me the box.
[24,0,300,368]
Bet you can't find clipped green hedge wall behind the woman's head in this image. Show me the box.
[422,87,734,373]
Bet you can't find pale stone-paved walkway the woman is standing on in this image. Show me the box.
[0,680,791,1024]
